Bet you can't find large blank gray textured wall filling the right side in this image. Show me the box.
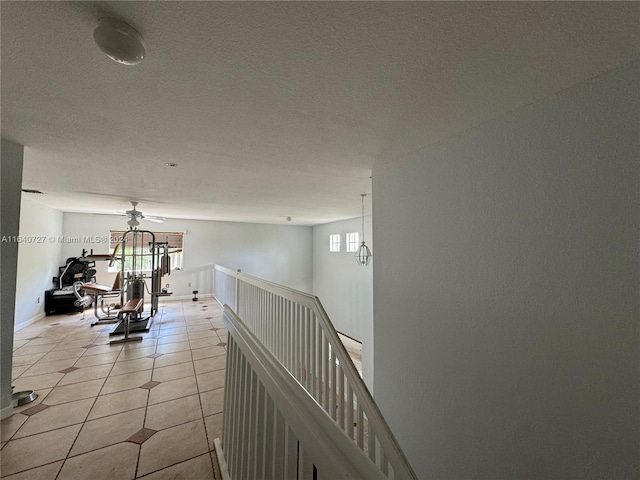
[373,62,640,479]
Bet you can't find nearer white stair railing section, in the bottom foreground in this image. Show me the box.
[215,306,387,480]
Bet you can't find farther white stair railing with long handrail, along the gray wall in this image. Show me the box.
[215,265,417,479]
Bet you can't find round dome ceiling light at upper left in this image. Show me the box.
[93,17,145,65]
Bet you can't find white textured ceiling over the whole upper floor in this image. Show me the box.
[0,1,640,225]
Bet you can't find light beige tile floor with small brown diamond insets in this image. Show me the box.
[0,298,227,480]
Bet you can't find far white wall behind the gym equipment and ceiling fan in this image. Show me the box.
[61,213,313,298]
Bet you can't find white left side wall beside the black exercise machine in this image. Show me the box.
[15,197,64,330]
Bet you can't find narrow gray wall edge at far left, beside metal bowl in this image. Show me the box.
[0,138,24,418]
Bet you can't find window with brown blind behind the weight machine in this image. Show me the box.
[108,230,184,272]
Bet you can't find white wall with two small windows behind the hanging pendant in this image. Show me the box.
[313,219,375,391]
